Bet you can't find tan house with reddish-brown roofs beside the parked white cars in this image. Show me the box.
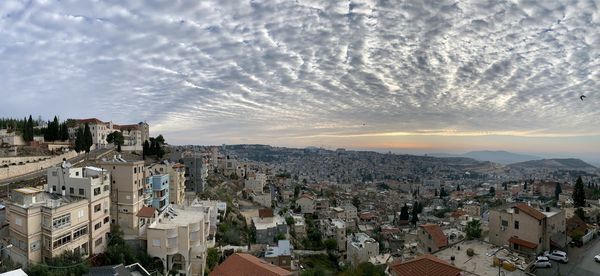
[489,203,566,254]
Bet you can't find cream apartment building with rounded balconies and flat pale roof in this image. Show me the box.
[147,206,210,276]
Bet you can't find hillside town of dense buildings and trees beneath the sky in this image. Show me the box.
[0,117,600,275]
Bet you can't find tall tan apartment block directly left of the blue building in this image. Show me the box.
[99,156,146,240]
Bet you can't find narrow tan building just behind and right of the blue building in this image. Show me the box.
[148,161,185,205]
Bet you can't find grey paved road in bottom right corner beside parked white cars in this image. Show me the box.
[536,238,600,276]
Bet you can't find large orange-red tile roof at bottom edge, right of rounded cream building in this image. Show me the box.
[209,253,293,276]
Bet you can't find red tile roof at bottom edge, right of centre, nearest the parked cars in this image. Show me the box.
[390,254,462,276]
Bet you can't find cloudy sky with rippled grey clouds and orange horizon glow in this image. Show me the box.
[0,0,600,159]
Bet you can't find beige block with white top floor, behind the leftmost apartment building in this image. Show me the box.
[47,165,111,254]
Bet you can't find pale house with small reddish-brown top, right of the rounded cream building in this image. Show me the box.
[252,209,287,244]
